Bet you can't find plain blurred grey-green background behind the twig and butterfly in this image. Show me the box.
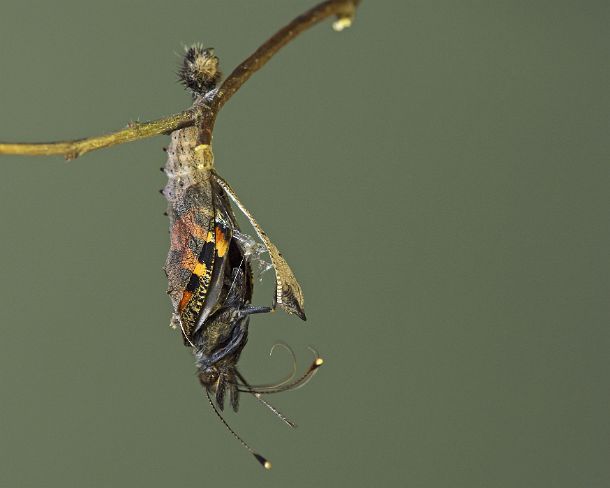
[0,0,610,488]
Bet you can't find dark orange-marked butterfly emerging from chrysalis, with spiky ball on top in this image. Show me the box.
[162,45,322,469]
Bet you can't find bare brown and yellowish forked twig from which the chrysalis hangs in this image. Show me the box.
[0,0,360,159]
